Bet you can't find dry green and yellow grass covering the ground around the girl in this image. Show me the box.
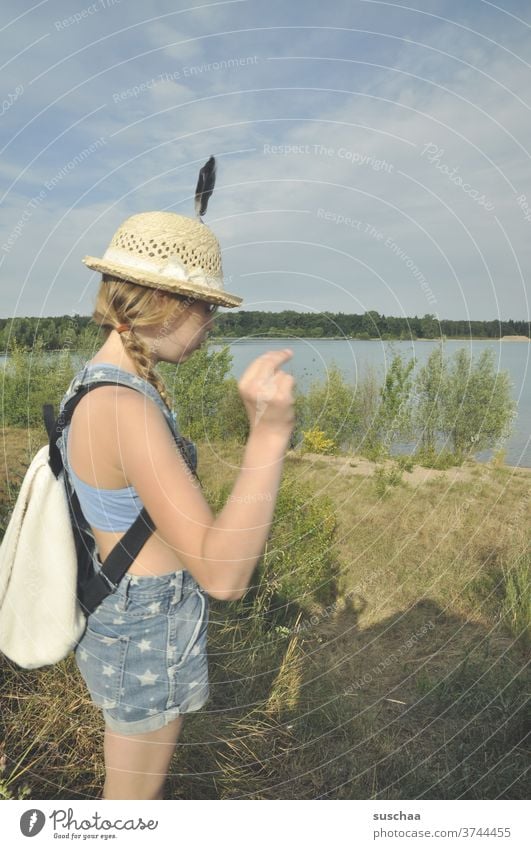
[0,429,531,799]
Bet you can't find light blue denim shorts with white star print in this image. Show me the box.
[75,560,209,734]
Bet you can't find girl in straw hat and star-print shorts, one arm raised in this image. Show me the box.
[61,202,300,799]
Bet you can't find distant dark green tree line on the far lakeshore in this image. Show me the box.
[0,310,530,352]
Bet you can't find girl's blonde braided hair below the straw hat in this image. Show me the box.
[92,274,192,410]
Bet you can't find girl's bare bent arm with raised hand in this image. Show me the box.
[115,351,295,600]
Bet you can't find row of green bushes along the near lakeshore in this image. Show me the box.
[2,339,516,468]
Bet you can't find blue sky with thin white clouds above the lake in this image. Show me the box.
[0,0,531,320]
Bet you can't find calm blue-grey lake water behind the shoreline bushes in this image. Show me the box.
[0,339,531,467]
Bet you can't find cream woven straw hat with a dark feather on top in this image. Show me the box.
[83,157,243,307]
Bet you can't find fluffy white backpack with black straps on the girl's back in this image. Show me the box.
[0,378,199,669]
